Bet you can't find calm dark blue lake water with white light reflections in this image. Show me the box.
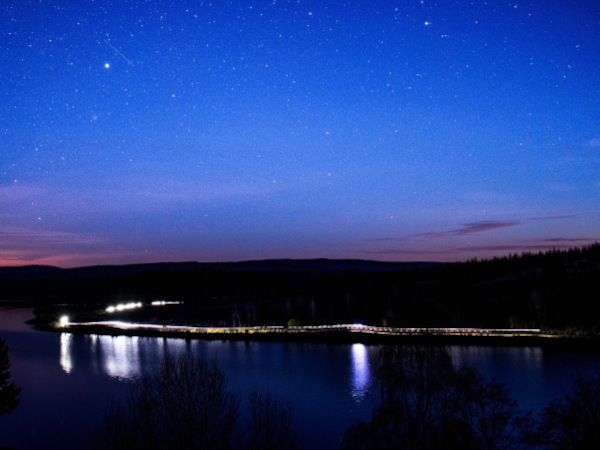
[0,308,600,448]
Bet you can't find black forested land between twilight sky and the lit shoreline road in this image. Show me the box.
[0,244,600,335]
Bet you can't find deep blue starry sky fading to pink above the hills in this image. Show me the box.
[0,0,600,267]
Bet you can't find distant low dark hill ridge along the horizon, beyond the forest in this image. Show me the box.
[0,259,439,282]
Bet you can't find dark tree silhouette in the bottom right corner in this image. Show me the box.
[539,375,600,450]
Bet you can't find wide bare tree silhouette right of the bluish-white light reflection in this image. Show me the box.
[342,346,529,449]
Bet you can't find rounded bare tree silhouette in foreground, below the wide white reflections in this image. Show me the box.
[98,357,238,449]
